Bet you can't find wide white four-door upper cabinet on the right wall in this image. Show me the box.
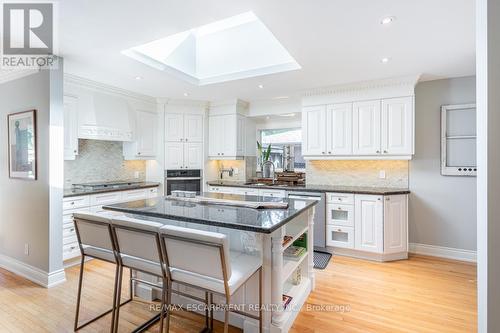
[302,96,414,159]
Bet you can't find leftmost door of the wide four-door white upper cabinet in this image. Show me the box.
[302,105,327,156]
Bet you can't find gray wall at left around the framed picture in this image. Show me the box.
[0,68,63,272]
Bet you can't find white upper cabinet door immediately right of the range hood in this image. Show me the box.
[135,111,158,157]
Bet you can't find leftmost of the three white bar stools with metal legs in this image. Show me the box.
[73,213,131,332]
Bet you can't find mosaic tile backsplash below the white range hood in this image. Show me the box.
[64,139,146,188]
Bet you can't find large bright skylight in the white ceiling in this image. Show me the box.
[122,12,300,85]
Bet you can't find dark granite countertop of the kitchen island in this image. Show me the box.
[103,193,317,234]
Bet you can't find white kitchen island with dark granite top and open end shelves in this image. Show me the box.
[103,193,316,333]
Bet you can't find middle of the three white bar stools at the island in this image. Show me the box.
[111,216,170,332]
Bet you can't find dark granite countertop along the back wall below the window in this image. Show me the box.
[207,181,410,195]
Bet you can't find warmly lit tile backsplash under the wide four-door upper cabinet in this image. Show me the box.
[306,160,409,188]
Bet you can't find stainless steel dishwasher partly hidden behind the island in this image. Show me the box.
[288,191,326,250]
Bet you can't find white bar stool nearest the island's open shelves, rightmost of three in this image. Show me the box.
[160,225,262,333]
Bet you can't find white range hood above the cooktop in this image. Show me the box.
[78,92,133,141]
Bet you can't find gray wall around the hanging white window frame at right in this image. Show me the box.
[409,77,476,250]
